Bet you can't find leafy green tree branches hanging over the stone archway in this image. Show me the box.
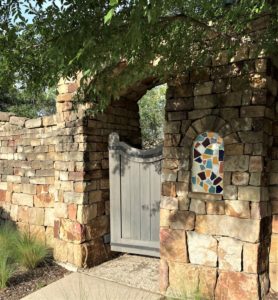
[0,0,278,108]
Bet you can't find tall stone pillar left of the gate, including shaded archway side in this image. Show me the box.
[54,77,141,267]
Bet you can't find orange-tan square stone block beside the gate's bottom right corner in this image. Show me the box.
[160,229,188,263]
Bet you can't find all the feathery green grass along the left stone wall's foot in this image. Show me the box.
[0,223,50,289]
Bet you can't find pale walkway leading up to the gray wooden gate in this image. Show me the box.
[22,255,163,300]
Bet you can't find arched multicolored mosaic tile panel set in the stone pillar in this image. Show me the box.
[191,132,224,194]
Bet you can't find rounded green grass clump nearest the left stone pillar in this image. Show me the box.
[15,233,50,269]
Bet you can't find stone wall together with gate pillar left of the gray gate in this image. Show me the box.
[0,80,141,267]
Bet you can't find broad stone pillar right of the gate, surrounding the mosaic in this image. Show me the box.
[160,48,277,299]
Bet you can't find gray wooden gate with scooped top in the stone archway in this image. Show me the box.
[109,133,162,257]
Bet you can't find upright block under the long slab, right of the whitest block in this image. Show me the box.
[218,237,242,271]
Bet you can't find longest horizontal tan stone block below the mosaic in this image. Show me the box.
[195,215,260,243]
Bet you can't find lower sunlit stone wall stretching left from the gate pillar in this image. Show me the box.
[0,113,59,246]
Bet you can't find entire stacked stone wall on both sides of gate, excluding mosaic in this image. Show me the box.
[0,49,278,300]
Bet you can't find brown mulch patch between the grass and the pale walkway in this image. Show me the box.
[0,263,70,300]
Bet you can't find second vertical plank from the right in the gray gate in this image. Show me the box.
[140,163,151,241]
